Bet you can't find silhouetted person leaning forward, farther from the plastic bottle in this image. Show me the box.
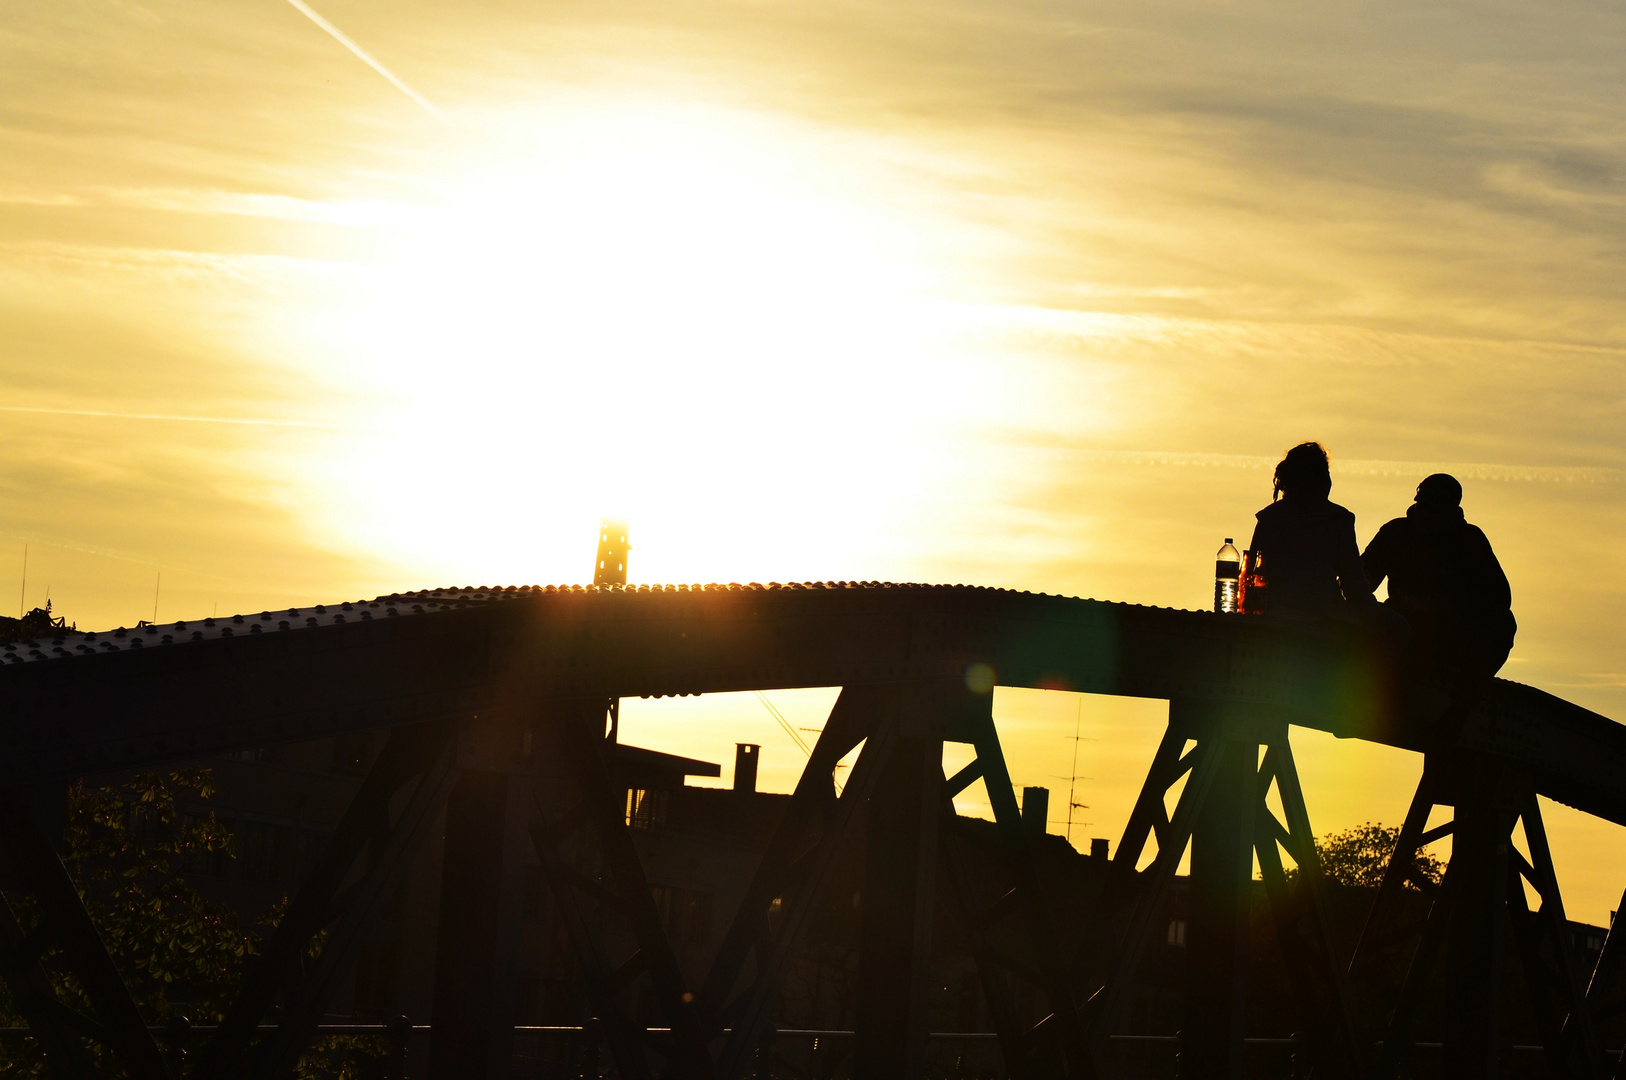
[1361,473,1519,682]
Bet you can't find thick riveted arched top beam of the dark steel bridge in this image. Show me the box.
[0,582,1626,821]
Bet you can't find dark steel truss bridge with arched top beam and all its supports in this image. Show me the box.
[0,582,1626,1080]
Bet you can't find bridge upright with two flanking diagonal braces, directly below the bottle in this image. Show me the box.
[1091,701,1363,1080]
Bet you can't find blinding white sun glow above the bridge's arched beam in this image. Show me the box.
[317,100,998,581]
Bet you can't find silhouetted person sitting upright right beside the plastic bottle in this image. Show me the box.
[1250,442,1382,620]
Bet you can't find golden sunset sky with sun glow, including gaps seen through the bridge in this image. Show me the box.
[0,0,1626,921]
